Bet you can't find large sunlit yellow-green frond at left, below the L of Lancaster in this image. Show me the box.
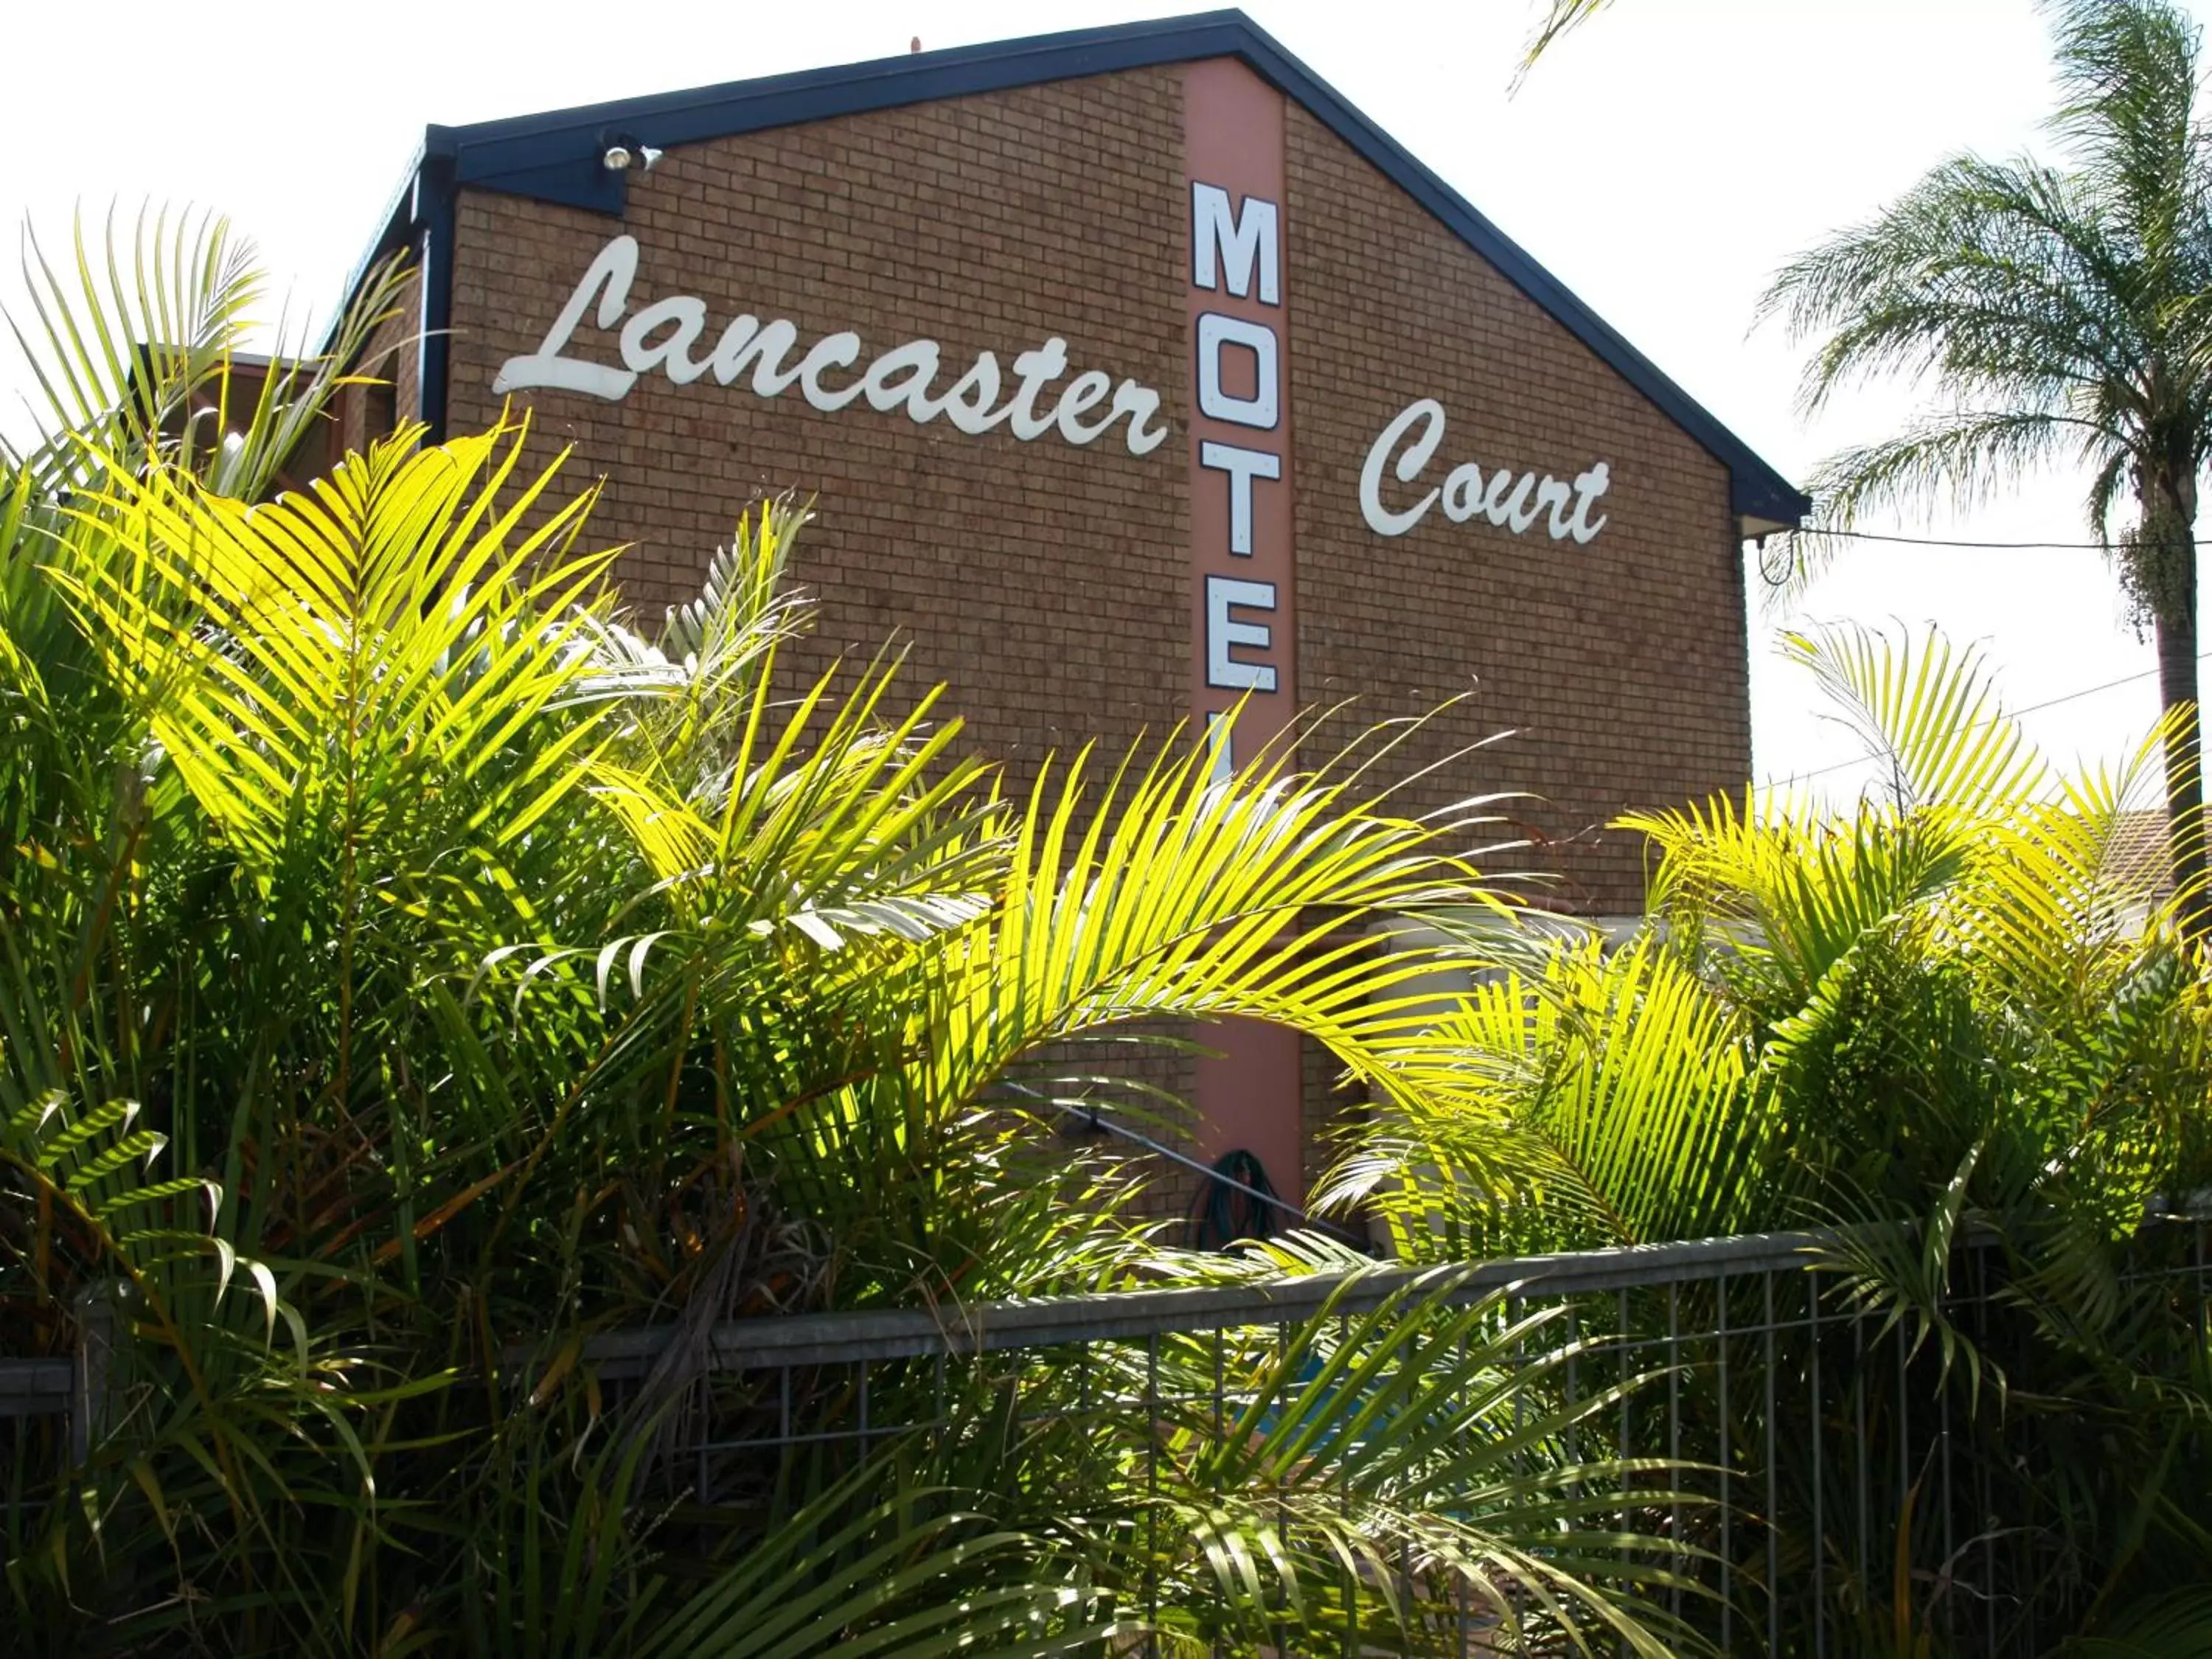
[55,431,611,858]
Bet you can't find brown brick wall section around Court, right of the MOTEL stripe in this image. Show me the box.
[1285,104,1752,914]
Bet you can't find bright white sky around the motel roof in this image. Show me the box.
[0,0,2177,792]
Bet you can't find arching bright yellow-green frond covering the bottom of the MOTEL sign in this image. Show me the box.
[911,708,1502,1110]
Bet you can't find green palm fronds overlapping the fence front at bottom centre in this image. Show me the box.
[1093,1267,1701,1659]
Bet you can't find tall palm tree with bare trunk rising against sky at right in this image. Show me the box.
[1761,0,2212,938]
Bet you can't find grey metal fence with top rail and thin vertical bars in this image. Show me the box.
[0,1214,2212,1659]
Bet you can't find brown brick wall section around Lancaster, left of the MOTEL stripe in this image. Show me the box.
[436,71,1190,776]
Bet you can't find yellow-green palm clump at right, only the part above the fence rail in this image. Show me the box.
[1327,626,2212,1261]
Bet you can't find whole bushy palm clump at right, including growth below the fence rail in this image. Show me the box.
[1325,628,2212,1659]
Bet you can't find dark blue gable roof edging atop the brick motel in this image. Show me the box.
[349,11,1812,533]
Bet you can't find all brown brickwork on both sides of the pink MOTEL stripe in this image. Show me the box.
[422,69,1750,1239]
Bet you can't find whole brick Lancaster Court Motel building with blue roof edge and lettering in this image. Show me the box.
[343,11,1807,1221]
